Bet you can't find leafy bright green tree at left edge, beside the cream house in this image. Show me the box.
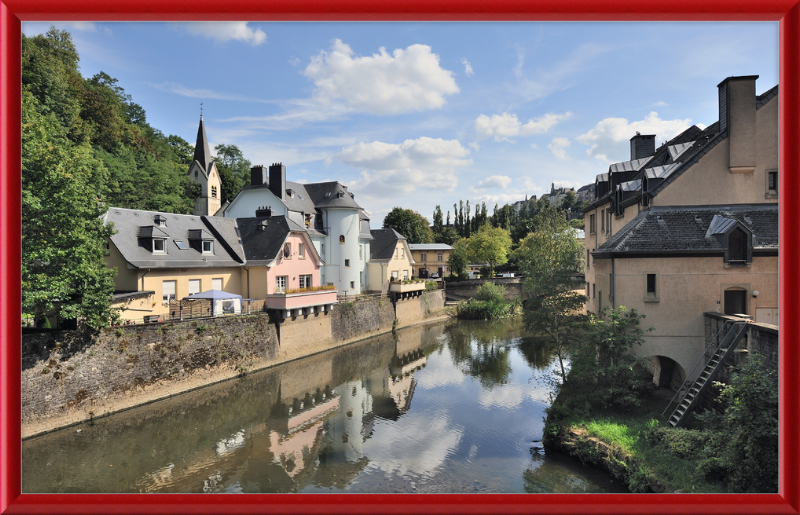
[22,88,116,328]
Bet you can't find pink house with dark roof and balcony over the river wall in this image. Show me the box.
[237,216,336,318]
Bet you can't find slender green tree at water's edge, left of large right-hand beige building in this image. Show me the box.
[512,208,586,382]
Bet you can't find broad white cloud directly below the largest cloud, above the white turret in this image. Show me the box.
[334,137,472,197]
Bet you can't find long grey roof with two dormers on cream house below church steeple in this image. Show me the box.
[103,208,244,268]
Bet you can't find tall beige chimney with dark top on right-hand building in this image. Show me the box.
[717,75,758,173]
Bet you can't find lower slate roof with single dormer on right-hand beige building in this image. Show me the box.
[592,204,778,258]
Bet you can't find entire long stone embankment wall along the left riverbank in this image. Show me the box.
[21,290,444,438]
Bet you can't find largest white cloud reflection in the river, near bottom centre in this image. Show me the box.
[369,414,463,476]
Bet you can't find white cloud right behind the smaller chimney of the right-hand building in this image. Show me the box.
[575,111,700,162]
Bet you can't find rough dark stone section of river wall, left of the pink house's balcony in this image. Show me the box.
[22,314,279,426]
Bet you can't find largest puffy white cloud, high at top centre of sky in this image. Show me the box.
[303,39,459,115]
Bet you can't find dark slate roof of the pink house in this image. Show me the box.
[236,216,321,266]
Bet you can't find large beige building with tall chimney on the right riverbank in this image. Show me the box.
[584,76,779,386]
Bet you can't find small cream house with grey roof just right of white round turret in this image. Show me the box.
[367,229,416,293]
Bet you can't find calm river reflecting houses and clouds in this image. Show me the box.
[22,321,627,493]
